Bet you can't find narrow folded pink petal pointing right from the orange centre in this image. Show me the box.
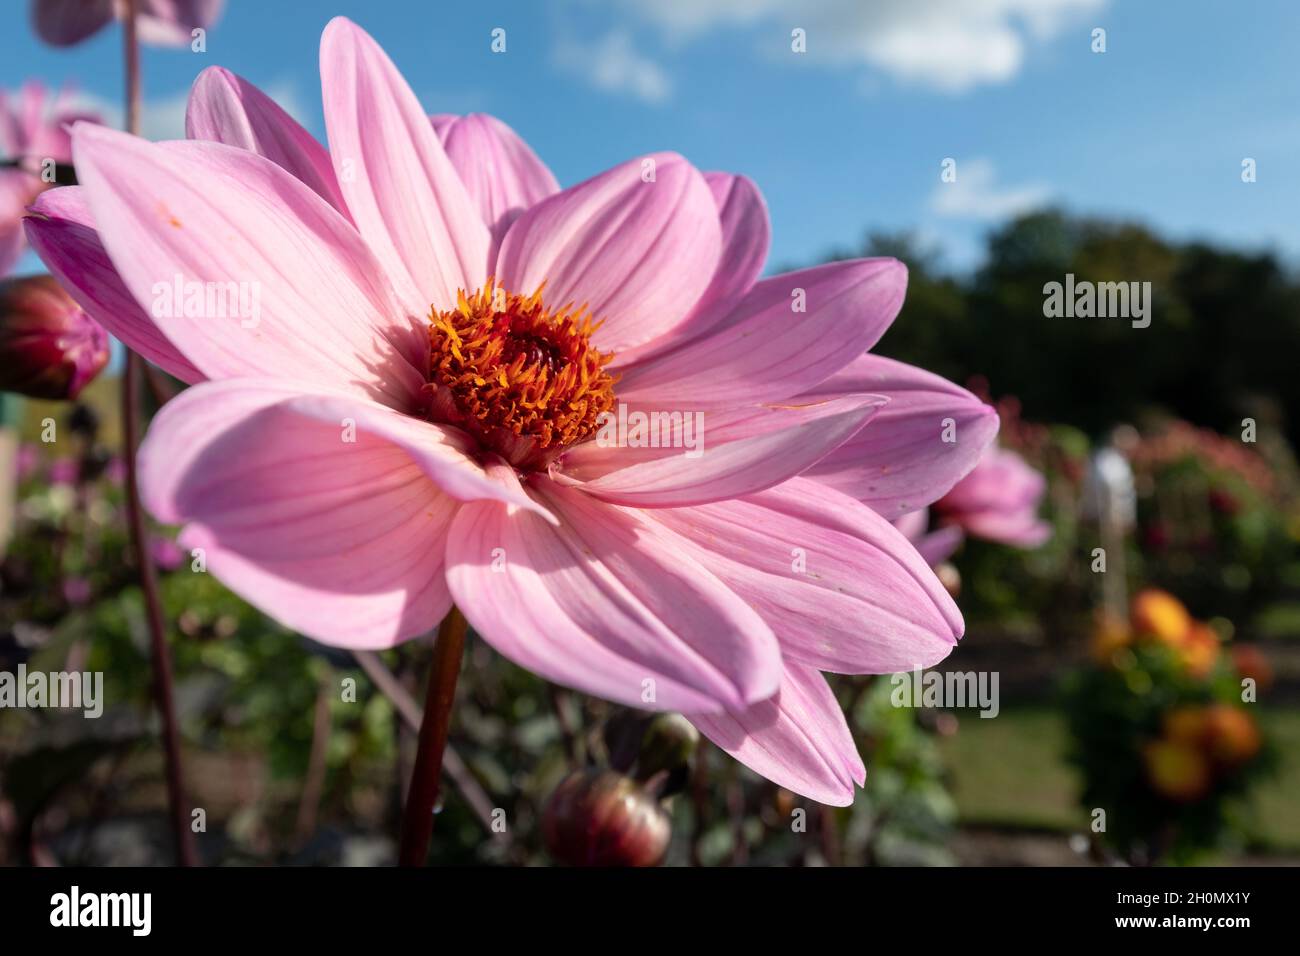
[560,395,885,507]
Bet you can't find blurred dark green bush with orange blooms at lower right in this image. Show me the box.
[1066,589,1273,864]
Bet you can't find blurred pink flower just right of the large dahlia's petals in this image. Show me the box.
[935,447,1052,548]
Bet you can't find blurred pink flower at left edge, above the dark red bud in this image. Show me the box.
[0,81,99,276]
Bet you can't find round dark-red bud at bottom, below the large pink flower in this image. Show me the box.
[542,770,672,866]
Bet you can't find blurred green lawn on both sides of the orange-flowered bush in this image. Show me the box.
[940,708,1300,852]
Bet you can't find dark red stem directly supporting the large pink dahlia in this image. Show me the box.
[398,607,468,866]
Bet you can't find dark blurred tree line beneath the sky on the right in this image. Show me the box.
[832,211,1300,445]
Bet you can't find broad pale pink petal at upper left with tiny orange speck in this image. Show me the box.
[73,124,428,408]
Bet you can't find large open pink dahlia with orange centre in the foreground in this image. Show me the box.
[29,20,997,804]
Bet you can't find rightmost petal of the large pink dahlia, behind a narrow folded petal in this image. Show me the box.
[805,355,998,518]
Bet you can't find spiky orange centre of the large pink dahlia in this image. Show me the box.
[429,278,615,470]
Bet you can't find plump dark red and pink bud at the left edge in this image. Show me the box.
[0,276,108,399]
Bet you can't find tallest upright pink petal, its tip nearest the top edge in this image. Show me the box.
[321,17,489,316]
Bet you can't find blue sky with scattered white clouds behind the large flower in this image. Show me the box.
[0,0,1300,277]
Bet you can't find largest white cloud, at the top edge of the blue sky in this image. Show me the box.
[608,0,1108,94]
